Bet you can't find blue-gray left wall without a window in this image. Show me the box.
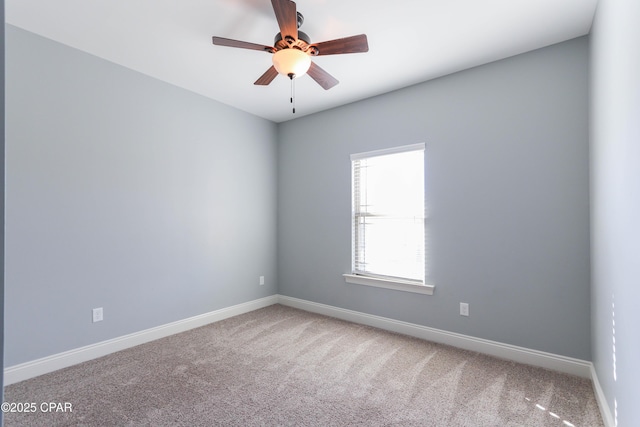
[5,26,277,366]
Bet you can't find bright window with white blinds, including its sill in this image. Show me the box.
[344,144,433,294]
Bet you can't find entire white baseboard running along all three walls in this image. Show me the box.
[4,295,615,427]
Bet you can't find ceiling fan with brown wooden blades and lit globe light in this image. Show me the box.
[213,0,369,90]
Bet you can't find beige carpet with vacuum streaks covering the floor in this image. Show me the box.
[5,305,603,427]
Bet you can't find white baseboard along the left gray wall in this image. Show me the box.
[4,295,278,385]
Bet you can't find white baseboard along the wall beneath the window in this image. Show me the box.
[278,295,592,378]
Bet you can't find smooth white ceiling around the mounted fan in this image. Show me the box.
[5,0,597,122]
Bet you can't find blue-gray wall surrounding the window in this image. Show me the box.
[278,37,591,360]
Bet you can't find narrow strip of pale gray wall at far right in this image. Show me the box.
[590,0,640,426]
